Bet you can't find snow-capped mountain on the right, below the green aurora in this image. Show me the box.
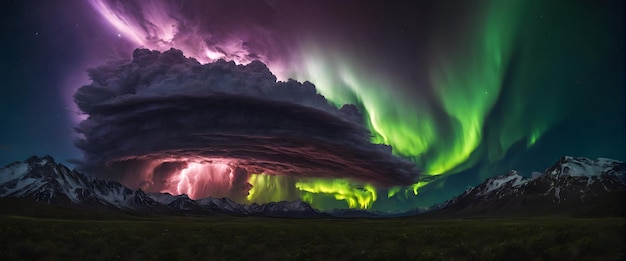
[442,156,626,215]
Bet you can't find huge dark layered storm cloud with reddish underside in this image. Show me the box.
[74,49,418,193]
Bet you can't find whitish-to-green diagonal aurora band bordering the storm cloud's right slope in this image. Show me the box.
[292,44,438,160]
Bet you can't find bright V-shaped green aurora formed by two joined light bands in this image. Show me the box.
[292,1,521,179]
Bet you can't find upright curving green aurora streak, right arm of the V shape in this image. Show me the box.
[429,1,523,173]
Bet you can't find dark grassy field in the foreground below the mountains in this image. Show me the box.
[0,201,625,260]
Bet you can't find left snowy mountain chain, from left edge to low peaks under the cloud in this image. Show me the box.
[0,156,326,217]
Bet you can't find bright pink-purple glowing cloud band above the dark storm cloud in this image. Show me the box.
[89,0,286,77]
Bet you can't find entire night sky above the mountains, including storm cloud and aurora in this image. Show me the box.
[0,0,626,210]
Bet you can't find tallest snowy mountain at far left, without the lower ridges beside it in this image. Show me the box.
[0,156,163,212]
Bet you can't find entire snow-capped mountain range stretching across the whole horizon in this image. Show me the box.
[0,156,626,218]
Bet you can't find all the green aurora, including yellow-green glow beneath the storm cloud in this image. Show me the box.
[243,0,623,209]
